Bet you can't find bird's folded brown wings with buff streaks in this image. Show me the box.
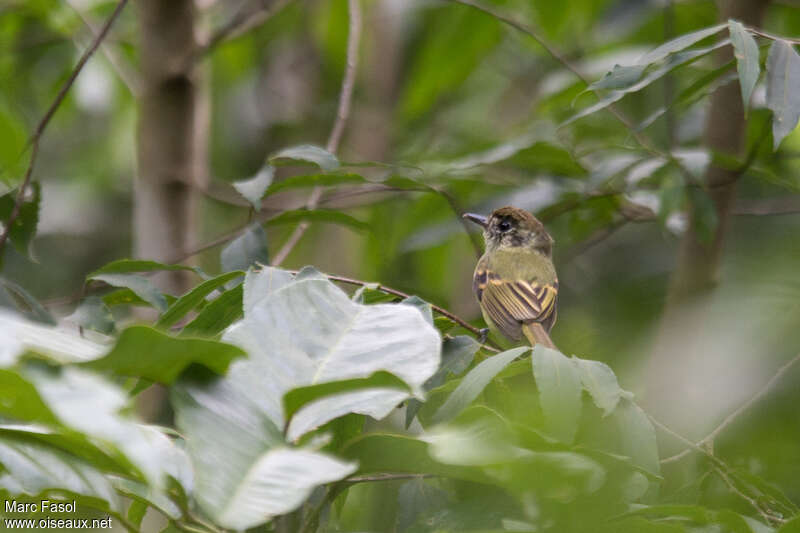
[473,262,558,340]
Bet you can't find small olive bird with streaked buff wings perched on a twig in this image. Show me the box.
[464,206,558,348]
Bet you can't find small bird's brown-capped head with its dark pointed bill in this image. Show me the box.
[464,206,553,257]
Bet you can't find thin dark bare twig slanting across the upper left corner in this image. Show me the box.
[0,0,128,254]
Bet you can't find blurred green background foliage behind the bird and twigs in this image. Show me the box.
[0,0,800,531]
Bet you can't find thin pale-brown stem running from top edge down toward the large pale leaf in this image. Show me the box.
[271,0,361,266]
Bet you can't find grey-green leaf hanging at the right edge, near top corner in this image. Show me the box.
[767,39,800,150]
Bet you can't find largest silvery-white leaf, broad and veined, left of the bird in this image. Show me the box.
[224,271,440,426]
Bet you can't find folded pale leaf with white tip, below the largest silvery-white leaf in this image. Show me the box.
[172,380,355,529]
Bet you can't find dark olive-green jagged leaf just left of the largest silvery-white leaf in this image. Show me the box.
[84,326,245,385]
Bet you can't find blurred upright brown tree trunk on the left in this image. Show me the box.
[134,0,204,293]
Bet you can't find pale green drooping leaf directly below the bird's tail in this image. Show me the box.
[532,344,582,444]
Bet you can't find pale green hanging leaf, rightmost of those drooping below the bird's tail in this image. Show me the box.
[610,399,661,476]
